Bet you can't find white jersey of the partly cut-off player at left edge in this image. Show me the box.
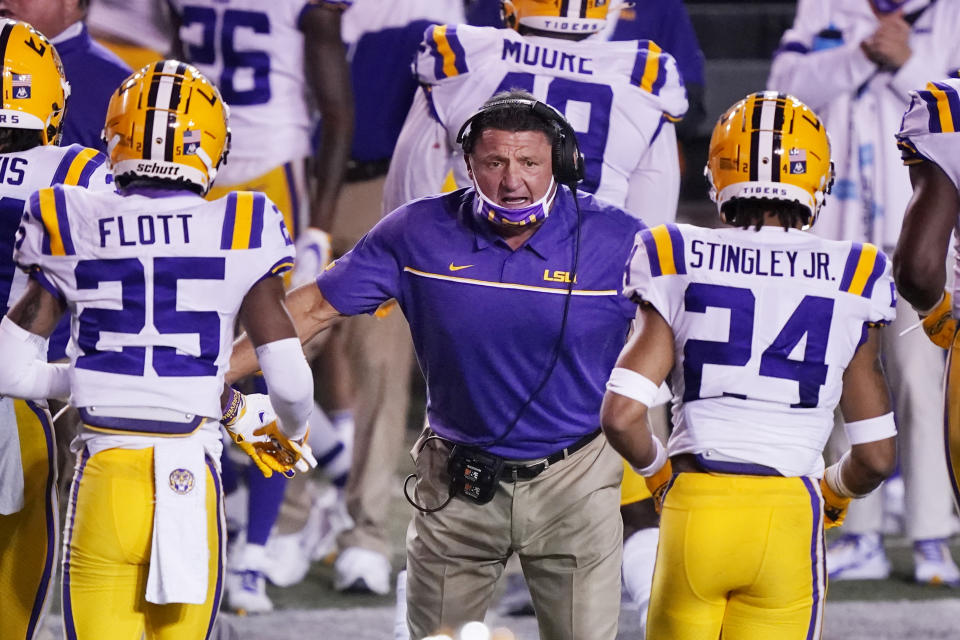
[0,144,114,316]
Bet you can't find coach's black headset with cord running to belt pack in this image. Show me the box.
[403,97,584,513]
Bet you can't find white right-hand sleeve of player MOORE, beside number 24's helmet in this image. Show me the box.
[624,120,680,227]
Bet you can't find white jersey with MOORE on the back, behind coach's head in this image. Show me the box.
[386,25,687,215]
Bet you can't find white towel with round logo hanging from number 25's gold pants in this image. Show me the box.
[146,438,210,604]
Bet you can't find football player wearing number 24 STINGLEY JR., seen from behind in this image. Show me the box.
[601,92,896,640]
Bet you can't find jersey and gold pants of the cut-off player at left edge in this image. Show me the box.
[0,145,113,640]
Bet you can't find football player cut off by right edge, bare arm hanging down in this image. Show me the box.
[893,77,960,516]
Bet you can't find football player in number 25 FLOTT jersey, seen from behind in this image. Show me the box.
[0,60,313,639]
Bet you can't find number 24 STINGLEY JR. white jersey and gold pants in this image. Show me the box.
[624,225,895,639]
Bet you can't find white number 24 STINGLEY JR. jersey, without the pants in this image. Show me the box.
[624,225,896,476]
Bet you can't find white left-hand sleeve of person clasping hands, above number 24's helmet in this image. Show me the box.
[767,0,877,111]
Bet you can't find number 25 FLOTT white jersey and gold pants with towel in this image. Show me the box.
[14,186,293,638]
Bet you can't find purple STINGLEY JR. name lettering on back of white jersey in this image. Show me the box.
[687,239,836,280]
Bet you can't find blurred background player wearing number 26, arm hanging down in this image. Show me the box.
[169,0,353,613]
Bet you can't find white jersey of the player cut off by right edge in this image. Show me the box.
[897,78,960,314]
